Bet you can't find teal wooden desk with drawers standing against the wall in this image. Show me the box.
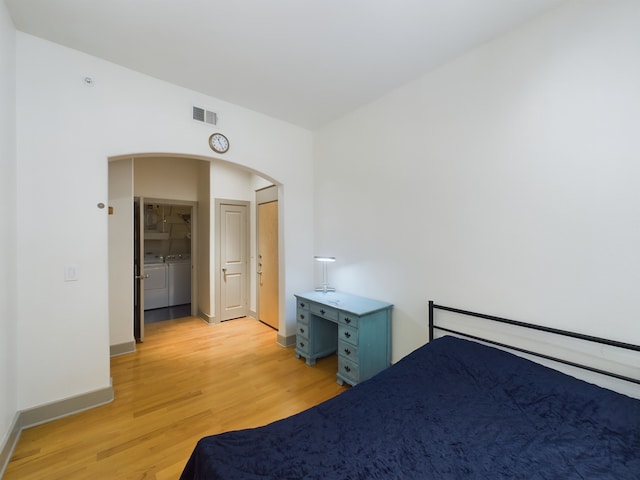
[296,292,393,386]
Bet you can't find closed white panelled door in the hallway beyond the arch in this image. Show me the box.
[218,202,249,321]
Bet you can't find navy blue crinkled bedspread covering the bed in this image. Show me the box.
[181,337,640,480]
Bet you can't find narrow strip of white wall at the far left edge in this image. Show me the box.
[0,2,18,450]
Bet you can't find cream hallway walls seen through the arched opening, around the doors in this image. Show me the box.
[109,153,284,355]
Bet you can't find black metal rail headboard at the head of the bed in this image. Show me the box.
[429,300,640,385]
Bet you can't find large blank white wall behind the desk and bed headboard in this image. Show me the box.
[314,0,640,372]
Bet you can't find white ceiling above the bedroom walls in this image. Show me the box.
[5,0,563,129]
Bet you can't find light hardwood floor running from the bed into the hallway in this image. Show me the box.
[3,318,348,480]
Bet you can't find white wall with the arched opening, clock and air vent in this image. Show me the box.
[17,33,313,409]
